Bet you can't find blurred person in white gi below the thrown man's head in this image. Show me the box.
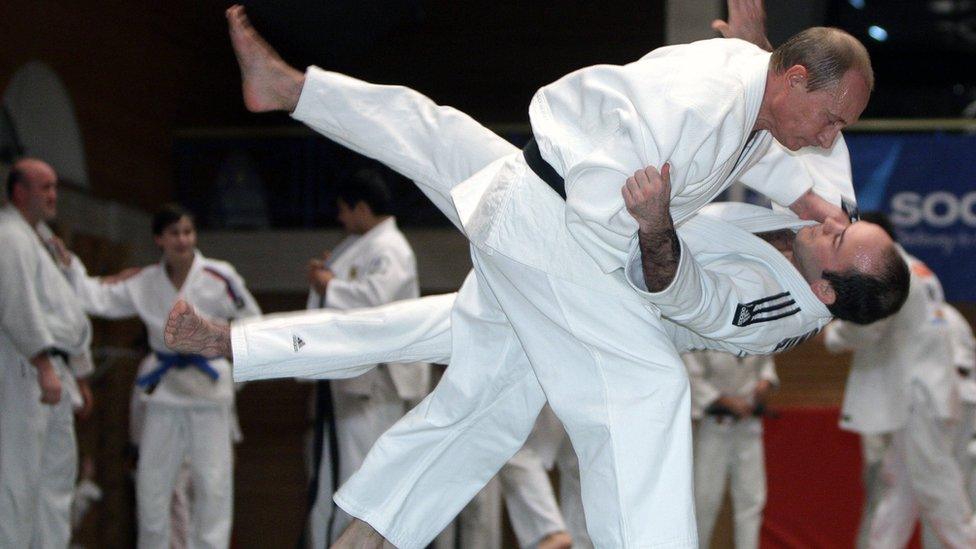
[824,216,976,549]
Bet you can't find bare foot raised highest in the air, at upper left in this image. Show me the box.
[227,5,305,112]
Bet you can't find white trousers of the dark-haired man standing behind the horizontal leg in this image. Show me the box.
[328,374,408,542]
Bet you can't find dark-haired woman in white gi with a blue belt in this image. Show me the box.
[58,205,260,549]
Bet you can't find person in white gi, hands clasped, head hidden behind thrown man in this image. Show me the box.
[682,351,779,549]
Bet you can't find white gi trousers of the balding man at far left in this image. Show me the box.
[0,358,78,549]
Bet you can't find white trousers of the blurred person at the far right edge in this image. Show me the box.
[870,385,976,549]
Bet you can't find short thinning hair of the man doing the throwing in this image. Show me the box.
[770,27,874,91]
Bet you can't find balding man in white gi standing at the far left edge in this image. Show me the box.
[0,158,92,547]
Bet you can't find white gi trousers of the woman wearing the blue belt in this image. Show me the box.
[136,402,234,549]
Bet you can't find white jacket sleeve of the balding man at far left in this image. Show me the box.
[0,235,55,358]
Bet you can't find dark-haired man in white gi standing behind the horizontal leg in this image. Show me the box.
[304,171,430,547]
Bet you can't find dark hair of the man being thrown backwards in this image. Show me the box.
[821,246,911,324]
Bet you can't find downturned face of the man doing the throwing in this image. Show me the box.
[770,65,871,151]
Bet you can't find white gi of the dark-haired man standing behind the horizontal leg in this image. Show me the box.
[308,217,430,547]
